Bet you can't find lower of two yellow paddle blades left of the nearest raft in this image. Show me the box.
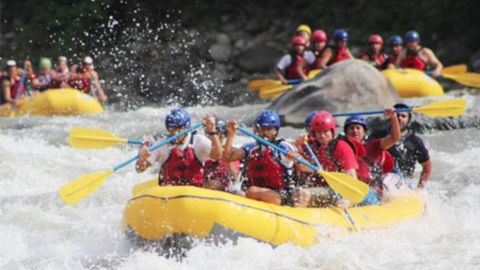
[58,169,113,205]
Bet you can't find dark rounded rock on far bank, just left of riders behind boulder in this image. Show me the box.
[236,45,282,73]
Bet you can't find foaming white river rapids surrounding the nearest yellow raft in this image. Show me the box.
[0,100,480,270]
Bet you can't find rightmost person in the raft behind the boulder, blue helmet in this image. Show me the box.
[395,31,443,78]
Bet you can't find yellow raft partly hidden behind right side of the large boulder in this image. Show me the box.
[382,69,444,97]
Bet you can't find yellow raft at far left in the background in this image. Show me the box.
[0,88,103,116]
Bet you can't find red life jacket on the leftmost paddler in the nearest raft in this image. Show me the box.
[158,134,203,186]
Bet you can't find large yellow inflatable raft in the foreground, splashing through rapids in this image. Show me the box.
[123,186,425,247]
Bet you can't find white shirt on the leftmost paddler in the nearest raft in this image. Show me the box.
[147,133,212,166]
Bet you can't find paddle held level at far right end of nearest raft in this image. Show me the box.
[332,99,467,117]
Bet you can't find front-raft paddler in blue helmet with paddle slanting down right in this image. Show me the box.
[224,110,299,205]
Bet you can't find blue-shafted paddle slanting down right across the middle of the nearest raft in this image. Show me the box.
[238,127,369,203]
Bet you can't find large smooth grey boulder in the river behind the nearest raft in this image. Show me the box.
[270,60,400,126]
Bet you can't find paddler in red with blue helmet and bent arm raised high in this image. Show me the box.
[343,108,402,200]
